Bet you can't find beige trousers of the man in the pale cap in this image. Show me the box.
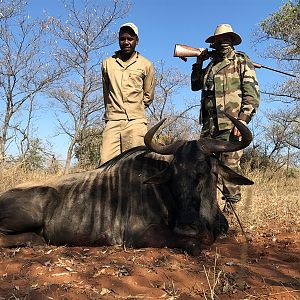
[101,119,147,164]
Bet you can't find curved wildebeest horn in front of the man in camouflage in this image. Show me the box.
[198,112,252,153]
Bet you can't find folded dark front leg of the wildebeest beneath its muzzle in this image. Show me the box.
[133,225,202,255]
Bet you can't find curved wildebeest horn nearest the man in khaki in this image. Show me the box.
[144,118,186,155]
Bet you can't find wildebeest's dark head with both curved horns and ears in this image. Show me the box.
[145,114,253,244]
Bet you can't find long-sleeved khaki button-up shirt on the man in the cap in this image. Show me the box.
[102,51,155,120]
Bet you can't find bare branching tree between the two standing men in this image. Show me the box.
[148,61,200,143]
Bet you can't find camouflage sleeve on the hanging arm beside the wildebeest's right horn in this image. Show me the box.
[238,54,260,123]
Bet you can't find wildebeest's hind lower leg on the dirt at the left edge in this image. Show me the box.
[0,232,46,248]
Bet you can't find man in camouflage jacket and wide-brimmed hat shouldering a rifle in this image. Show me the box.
[191,24,260,202]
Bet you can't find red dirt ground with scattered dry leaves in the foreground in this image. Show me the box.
[0,226,300,300]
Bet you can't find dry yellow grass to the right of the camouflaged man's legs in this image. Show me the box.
[225,171,300,230]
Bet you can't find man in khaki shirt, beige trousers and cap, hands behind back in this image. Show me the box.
[101,23,154,164]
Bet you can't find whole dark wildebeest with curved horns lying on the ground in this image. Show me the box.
[0,116,253,253]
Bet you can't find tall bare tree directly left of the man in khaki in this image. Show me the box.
[48,0,129,173]
